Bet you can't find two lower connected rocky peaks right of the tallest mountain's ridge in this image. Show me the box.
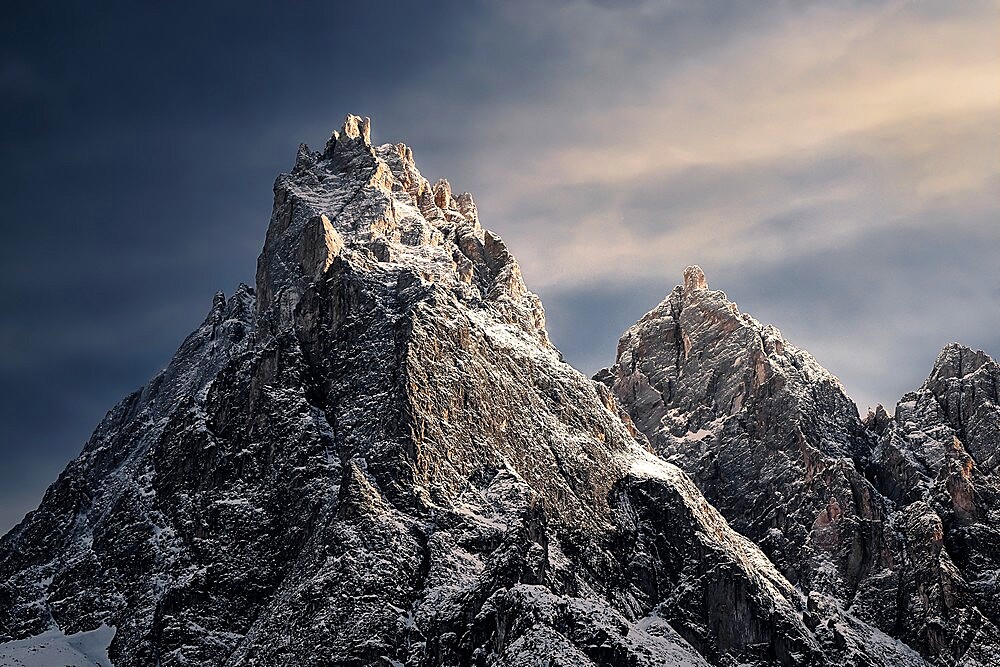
[597,267,1000,665]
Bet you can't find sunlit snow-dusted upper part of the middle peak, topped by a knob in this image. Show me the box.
[598,266,857,434]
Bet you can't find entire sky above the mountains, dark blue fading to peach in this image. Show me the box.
[0,0,1000,532]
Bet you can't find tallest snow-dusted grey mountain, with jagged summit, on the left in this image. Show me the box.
[0,116,923,667]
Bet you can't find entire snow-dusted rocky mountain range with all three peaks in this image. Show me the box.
[0,116,1000,667]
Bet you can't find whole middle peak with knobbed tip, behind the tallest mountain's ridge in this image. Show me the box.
[597,266,883,596]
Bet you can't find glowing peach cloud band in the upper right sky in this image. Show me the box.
[470,3,1000,235]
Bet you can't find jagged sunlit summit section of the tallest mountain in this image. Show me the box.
[250,116,547,341]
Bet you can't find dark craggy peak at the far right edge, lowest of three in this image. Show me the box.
[866,343,1000,665]
